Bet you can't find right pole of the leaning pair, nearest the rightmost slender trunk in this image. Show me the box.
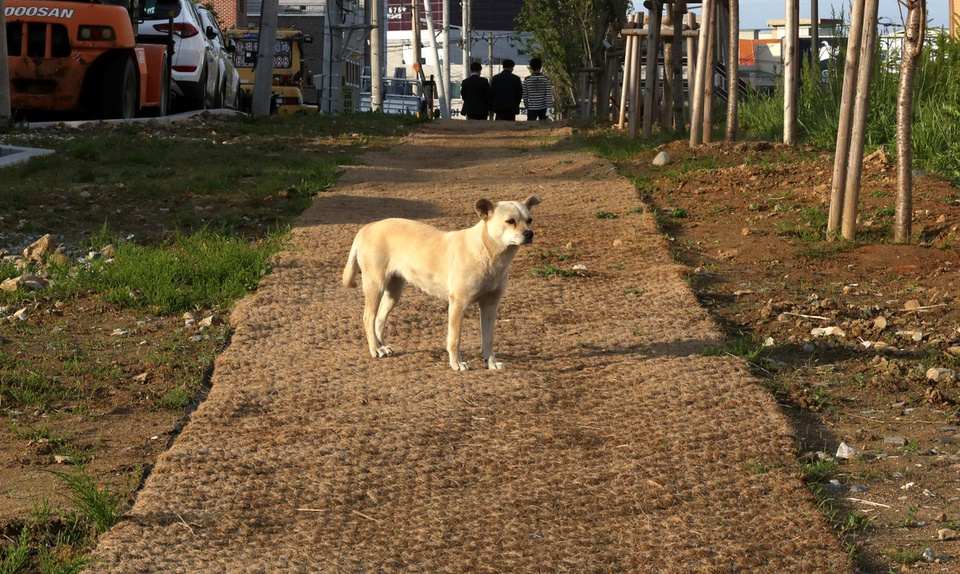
[841,0,879,240]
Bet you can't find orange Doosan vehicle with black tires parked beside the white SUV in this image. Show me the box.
[4,0,180,118]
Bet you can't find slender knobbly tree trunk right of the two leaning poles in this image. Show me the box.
[893,0,926,243]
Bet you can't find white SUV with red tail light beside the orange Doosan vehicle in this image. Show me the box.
[138,0,220,108]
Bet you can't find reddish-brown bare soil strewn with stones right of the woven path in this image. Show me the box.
[618,142,960,572]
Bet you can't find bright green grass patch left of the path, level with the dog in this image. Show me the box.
[65,231,281,314]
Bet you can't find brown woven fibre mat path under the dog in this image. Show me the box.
[94,122,849,573]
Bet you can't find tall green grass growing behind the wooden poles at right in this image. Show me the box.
[740,34,960,181]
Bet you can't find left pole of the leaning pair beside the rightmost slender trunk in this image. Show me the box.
[827,0,864,239]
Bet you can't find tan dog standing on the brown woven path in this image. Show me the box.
[343,196,540,371]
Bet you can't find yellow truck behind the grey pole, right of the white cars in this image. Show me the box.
[226,28,316,113]
